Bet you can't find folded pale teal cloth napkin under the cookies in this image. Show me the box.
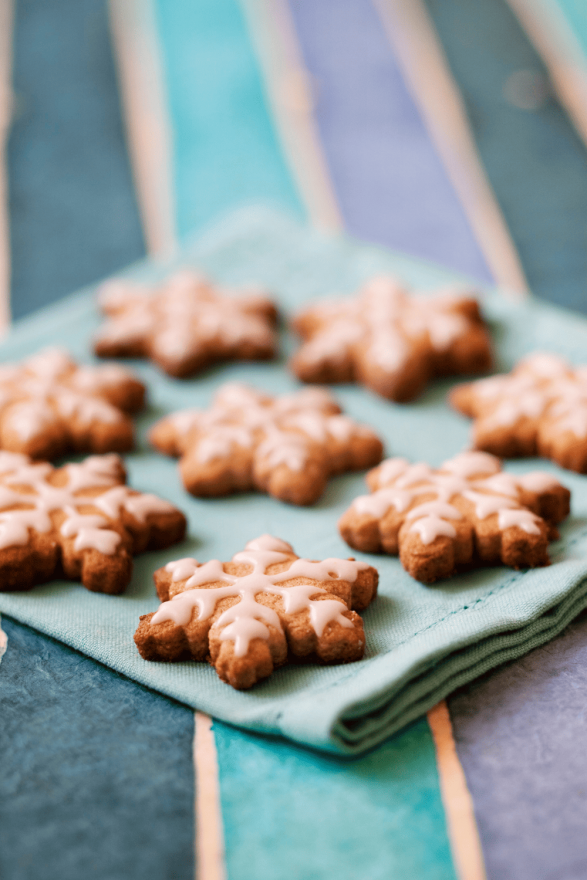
[0,208,587,754]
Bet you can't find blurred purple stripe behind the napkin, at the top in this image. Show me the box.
[290,0,491,280]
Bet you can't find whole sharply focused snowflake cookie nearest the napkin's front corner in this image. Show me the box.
[135,535,378,690]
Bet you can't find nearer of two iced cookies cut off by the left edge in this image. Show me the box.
[0,452,186,593]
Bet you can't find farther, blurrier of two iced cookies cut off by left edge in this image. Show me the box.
[0,348,145,459]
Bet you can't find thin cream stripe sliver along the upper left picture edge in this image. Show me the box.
[0,0,14,333]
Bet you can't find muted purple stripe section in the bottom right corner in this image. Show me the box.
[449,614,587,880]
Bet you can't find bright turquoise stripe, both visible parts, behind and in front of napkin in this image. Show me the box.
[154,0,455,880]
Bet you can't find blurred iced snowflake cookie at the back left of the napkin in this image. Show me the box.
[94,270,277,377]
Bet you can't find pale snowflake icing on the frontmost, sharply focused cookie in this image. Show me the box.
[151,535,369,657]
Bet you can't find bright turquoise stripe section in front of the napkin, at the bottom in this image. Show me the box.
[214,719,455,880]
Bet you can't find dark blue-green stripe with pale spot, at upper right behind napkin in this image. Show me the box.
[428,0,587,311]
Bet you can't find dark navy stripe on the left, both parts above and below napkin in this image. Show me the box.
[0,0,194,880]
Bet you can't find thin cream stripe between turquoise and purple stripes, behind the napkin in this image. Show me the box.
[241,0,343,231]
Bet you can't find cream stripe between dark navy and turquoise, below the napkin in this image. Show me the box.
[194,712,226,880]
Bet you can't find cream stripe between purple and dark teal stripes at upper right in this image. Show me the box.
[374,0,528,296]
